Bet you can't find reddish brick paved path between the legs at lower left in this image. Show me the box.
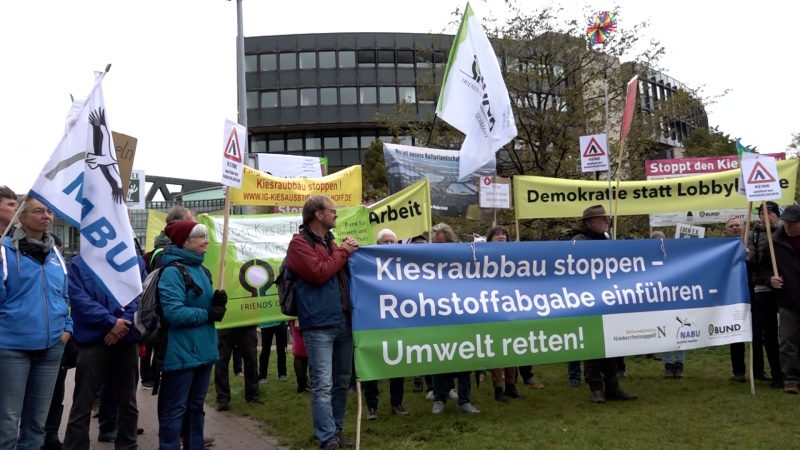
[59,370,287,450]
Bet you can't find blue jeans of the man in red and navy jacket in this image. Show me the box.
[303,325,353,447]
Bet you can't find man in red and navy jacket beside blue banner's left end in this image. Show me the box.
[286,194,358,450]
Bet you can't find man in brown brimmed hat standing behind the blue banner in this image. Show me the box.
[572,205,637,403]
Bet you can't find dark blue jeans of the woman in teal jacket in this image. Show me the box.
[158,365,214,450]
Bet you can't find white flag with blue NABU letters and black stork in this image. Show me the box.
[30,73,142,306]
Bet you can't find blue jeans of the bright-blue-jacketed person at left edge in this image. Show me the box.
[0,341,64,450]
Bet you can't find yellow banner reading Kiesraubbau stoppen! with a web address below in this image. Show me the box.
[231,166,361,206]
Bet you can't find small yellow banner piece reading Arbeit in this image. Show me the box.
[368,177,431,245]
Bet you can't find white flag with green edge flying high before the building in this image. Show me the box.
[436,3,517,180]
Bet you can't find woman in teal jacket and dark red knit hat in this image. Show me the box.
[158,220,228,450]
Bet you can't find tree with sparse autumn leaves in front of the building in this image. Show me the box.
[378,0,720,239]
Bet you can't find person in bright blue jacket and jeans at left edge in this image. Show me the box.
[0,198,72,449]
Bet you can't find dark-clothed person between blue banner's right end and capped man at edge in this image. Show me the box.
[747,202,783,389]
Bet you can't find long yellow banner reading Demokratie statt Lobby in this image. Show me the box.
[514,159,798,219]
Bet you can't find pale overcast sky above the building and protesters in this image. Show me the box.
[0,0,800,193]
